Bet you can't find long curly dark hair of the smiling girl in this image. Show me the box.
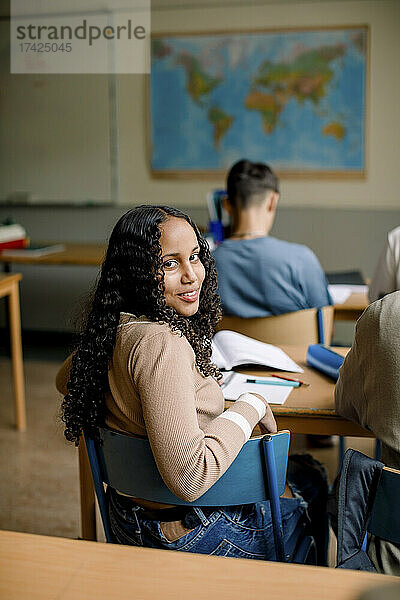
[61,205,221,445]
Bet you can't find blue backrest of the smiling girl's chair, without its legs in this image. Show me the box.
[91,429,290,506]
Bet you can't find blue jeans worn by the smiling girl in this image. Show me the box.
[108,454,327,564]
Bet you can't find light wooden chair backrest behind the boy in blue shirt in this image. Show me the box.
[217,306,334,345]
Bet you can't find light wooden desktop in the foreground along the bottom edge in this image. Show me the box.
[0,531,399,600]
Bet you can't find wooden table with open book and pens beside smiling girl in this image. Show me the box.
[79,346,373,540]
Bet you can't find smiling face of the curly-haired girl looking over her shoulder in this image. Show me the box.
[160,217,205,317]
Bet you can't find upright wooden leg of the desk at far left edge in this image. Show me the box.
[8,283,26,431]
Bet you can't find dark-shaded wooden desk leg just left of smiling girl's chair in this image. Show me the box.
[79,437,97,541]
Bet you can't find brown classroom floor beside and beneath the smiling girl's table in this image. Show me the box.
[0,358,373,556]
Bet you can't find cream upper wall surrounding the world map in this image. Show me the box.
[119,0,400,209]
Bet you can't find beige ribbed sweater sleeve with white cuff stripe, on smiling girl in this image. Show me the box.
[131,331,265,502]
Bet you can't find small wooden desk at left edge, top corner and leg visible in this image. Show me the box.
[0,273,26,431]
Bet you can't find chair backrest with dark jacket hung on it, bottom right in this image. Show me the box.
[337,449,400,570]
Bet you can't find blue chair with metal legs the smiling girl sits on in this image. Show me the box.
[85,428,316,564]
